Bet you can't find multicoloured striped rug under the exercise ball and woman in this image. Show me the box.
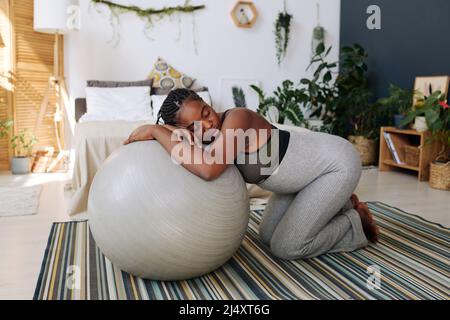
[34,202,450,300]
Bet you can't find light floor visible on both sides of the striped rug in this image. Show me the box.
[0,169,450,299]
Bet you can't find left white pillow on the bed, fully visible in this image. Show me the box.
[86,87,153,121]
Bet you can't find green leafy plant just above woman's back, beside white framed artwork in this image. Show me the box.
[251,80,305,126]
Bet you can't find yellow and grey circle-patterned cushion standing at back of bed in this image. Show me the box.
[149,57,195,92]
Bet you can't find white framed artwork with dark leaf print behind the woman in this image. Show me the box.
[220,78,260,111]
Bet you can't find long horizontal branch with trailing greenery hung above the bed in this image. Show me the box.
[91,0,205,49]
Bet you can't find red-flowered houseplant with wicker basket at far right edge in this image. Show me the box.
[402,91,450,190]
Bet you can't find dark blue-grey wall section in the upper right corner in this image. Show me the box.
[341,0,450,97]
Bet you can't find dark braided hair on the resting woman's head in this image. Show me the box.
[156,88,203,126]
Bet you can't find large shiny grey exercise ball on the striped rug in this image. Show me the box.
[88,141,249,280]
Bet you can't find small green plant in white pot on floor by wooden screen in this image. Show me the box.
[10,130,37,174]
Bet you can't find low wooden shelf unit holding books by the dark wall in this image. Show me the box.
[378,127,439,181]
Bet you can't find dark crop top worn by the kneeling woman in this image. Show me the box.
[222,110,290,184]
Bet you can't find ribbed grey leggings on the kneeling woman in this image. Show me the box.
[259,130,367,259]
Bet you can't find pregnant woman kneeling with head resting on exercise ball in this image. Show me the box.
[124,89,378,259]
